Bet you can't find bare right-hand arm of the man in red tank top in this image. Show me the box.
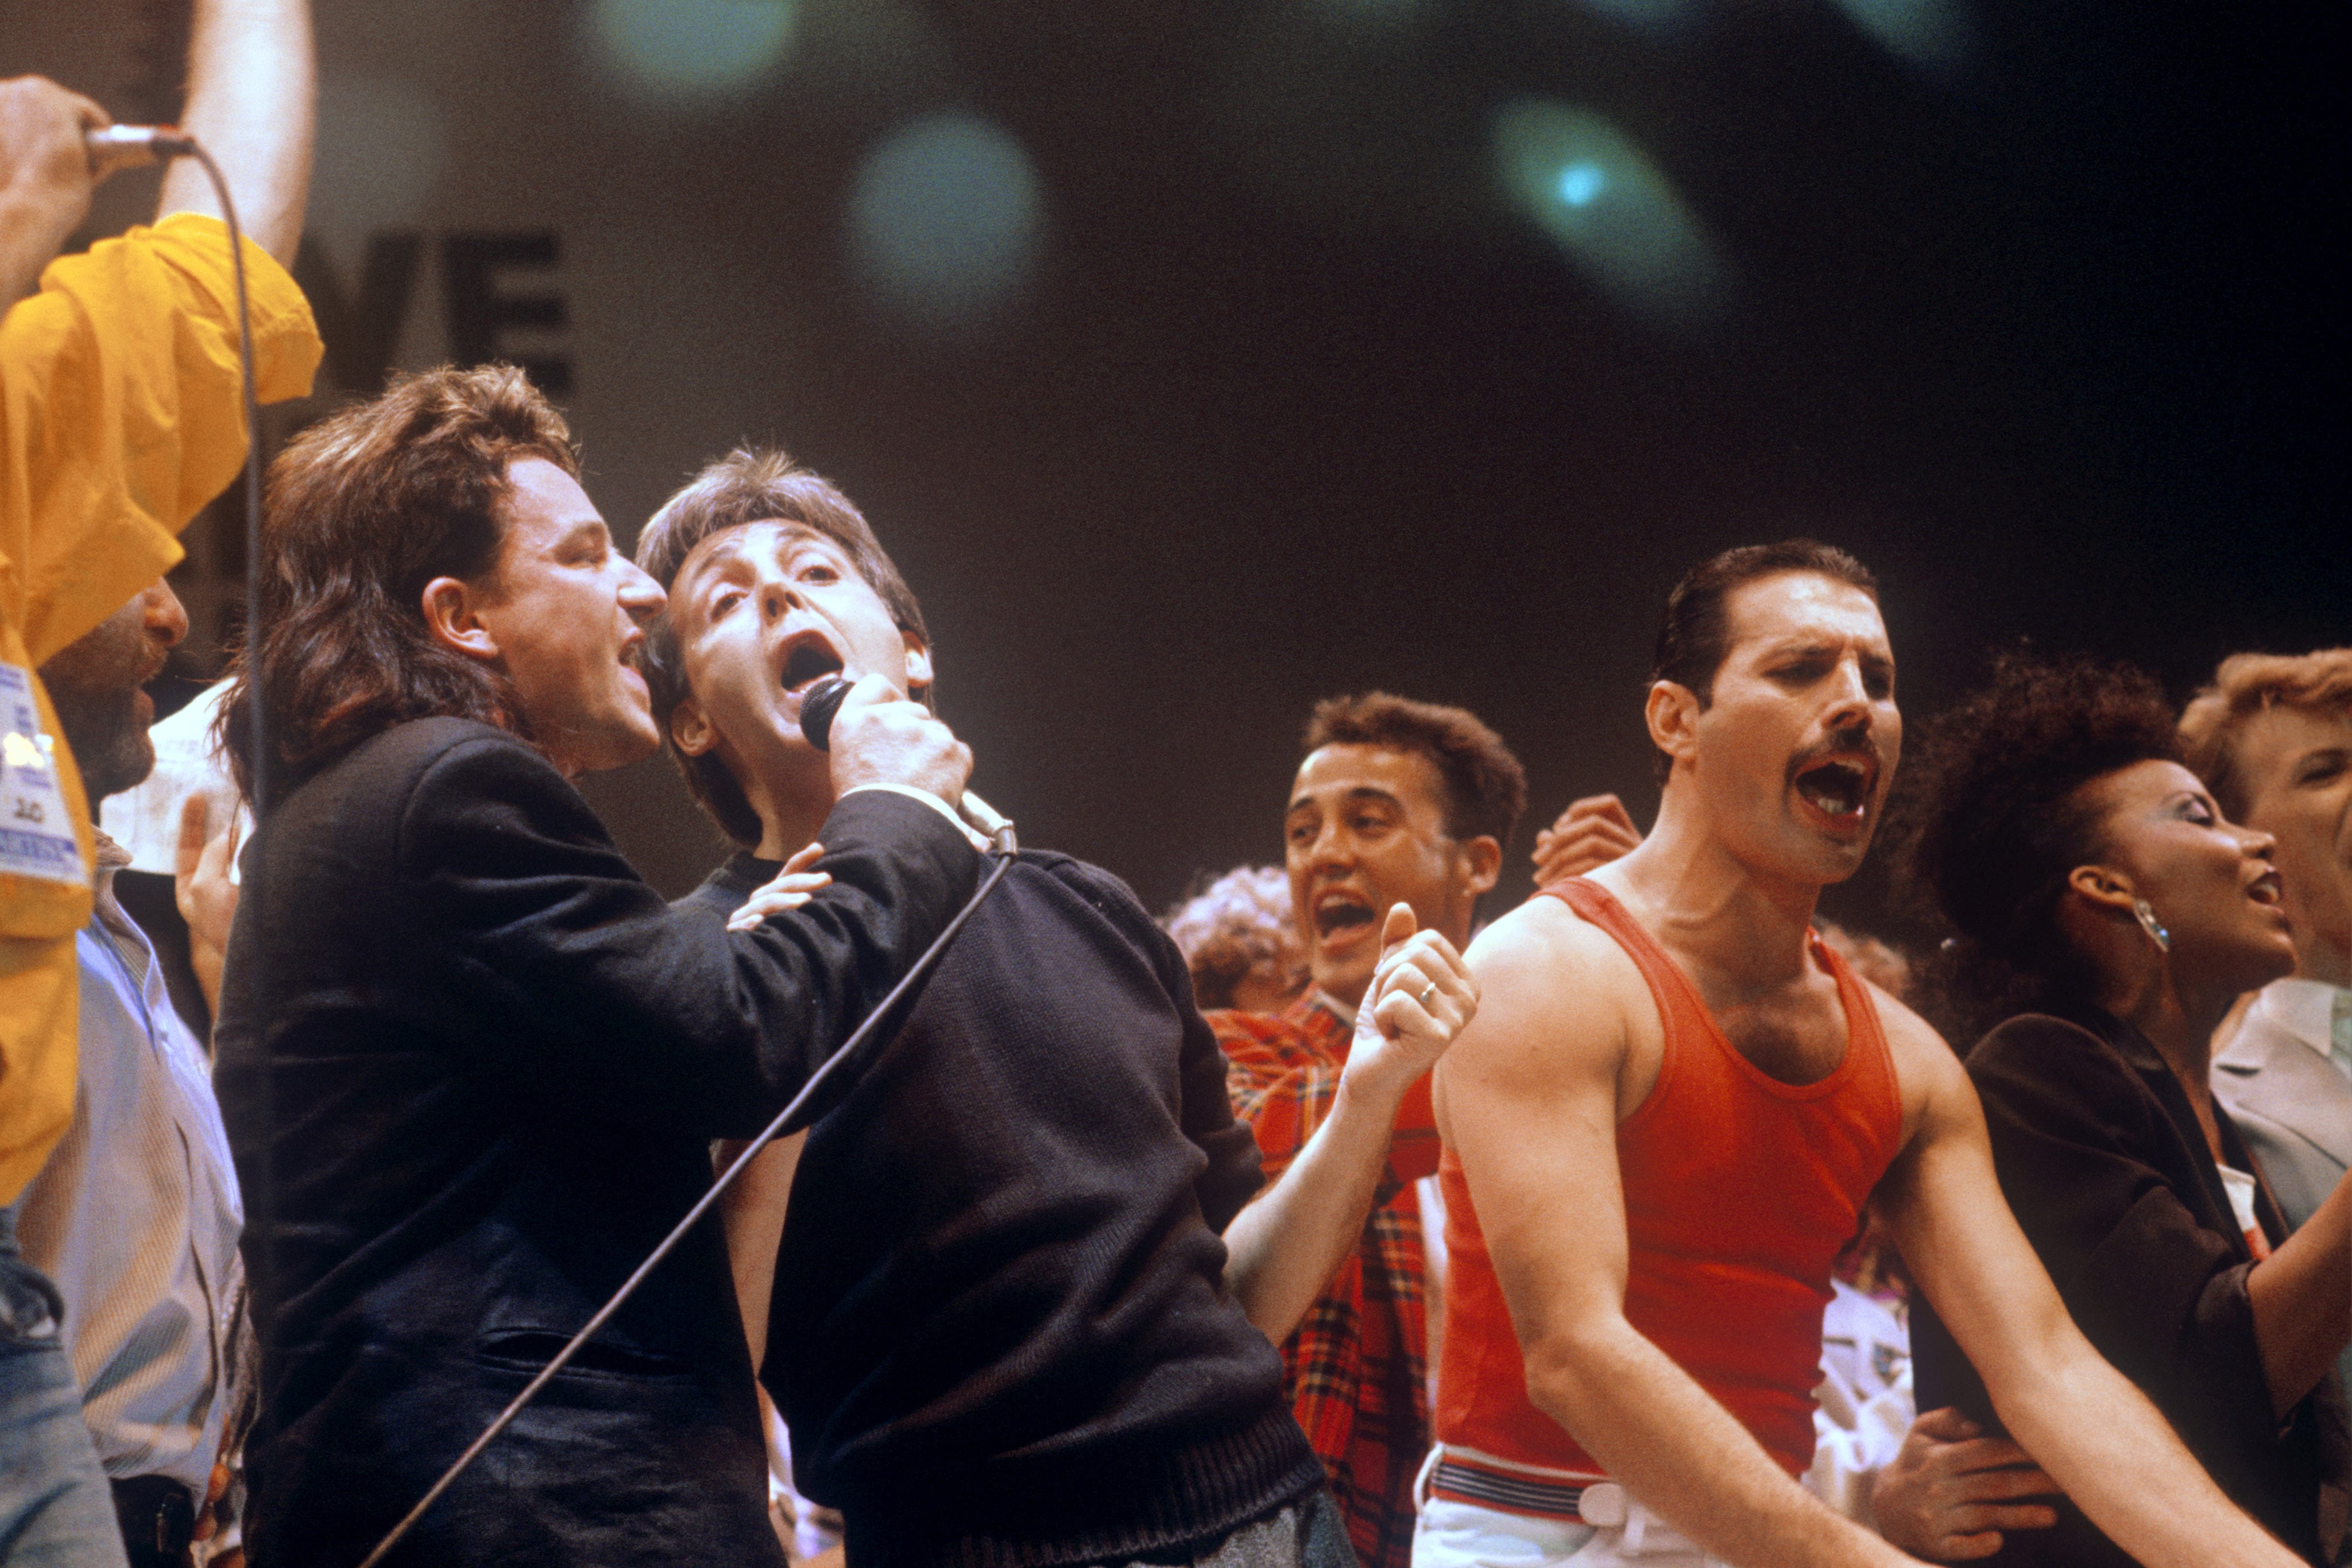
[1879,997,2298,1568]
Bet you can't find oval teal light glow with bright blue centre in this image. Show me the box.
[1494,99,1724,322]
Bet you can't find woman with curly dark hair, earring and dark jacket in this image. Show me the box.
[1908,656,2352,1566]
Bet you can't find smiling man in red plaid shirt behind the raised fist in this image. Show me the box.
[1209,694,1526,1568]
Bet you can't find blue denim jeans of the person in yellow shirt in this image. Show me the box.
[0,1203,125,1568]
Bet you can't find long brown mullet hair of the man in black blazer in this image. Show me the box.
[216,365,579,806]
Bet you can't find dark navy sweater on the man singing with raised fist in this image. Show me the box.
[687,853,1324,1568]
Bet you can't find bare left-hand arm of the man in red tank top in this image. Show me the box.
[1437,898,1912,1568]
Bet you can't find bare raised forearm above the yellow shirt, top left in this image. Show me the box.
[155,0,318,266]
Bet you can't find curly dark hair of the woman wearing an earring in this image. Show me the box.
[1895,649,2180,1035]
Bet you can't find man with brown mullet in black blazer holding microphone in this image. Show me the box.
[219,367,978,1568]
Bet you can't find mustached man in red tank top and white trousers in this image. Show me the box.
[1414,541,2296,1568]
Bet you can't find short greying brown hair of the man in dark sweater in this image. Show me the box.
[637,447,931,846]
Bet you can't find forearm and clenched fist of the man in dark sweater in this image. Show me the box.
[1225,903,1477,1345]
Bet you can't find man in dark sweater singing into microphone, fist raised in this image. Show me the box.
[637,451,1475,1568]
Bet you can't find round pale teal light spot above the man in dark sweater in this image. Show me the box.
[849,113,1045,327]
